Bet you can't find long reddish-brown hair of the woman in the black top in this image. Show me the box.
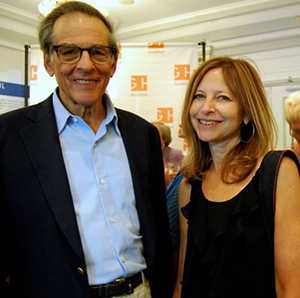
[181,57,277,183]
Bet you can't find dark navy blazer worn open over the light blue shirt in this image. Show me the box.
[0,96,173,298]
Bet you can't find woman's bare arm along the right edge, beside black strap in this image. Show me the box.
[274,157,300,298]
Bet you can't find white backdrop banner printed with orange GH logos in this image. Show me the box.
[30,43,198,149]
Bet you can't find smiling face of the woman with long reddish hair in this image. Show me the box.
[190,68,244,148]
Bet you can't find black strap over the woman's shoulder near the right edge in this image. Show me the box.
[259,150,300,253]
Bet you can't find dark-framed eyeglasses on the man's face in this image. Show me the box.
[51,45,117,64]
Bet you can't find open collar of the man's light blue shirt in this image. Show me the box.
[52,88,121,136]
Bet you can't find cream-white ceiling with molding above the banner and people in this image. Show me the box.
[0,0,300,55]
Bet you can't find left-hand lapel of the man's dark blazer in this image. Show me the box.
[20,98,84,262]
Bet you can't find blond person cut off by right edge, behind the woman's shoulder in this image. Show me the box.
[284,91,300,161]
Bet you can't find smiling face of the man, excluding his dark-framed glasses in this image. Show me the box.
[44,12,117,114]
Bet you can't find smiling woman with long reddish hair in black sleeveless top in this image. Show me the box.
[174,57,300,298]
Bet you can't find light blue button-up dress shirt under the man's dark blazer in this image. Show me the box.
[53,92,146,285]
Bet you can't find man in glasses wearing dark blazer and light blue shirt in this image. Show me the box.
[0,2,173,298]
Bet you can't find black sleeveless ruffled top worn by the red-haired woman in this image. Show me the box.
[182,151,298,298]
